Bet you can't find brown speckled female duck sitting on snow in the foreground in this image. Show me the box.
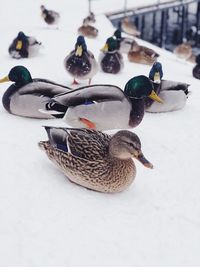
[39,127,153,193]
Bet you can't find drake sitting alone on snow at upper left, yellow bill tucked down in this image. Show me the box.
[8,31,41,59]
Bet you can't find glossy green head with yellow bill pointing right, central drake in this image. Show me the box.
[124,75,163,103]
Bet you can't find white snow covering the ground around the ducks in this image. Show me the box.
[0,0,200,267]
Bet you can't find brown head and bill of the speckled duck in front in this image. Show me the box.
[109,130,153,169]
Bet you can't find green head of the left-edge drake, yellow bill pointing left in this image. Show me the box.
[0,66,32,86]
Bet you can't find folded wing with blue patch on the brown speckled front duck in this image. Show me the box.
[45,126,111,161]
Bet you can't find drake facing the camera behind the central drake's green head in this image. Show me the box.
[145,62,189,112]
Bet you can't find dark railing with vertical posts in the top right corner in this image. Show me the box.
[107,0,200,53]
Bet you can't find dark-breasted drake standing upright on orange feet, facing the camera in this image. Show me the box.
[64,35,98,84]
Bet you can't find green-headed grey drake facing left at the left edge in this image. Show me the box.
[0,66,70,119]
